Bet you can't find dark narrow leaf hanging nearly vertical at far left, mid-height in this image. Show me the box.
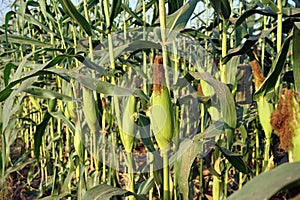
[34,112,51,161]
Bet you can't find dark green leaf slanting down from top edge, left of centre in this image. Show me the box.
[59,0,93,36]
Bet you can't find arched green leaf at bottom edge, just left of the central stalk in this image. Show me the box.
[82,184,147,200]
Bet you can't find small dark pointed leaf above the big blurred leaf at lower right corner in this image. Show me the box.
[216,143,249,174]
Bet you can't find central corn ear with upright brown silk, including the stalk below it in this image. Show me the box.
[150,56,174,200]
